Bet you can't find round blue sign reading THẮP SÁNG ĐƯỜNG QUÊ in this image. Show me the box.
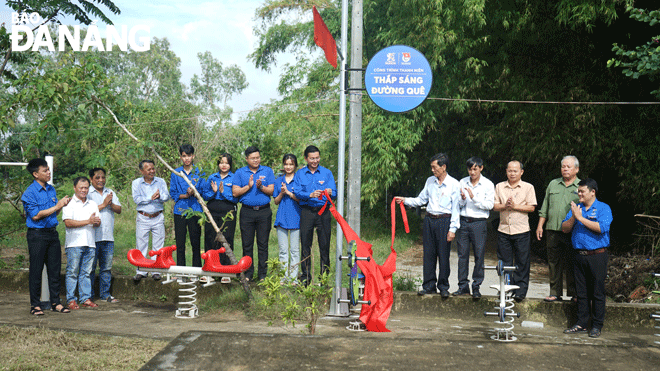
[364,45,433,112]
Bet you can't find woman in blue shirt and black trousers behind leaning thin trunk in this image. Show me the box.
[202,153,237,283]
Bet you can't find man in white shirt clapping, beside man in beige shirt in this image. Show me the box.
[453,157,495,299]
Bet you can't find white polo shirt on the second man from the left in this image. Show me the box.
[62,195,100,247]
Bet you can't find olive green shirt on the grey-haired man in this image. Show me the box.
[539,178,580,231]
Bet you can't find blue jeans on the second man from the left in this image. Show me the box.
[66,246,96,303]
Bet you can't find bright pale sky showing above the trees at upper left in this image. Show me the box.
[0,0,311,120]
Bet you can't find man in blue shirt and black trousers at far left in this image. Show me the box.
[21,158,71,316]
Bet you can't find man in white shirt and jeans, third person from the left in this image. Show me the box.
[87,167,121,303]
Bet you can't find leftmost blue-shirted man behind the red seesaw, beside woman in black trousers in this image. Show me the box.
[170,144,204,267]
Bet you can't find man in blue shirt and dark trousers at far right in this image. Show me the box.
[561,178,612,338]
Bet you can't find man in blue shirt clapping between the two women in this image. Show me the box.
[232,146,275,280]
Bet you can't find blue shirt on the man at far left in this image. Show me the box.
[21,180,57,228]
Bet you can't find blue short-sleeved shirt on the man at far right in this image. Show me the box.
[562,199,612,250]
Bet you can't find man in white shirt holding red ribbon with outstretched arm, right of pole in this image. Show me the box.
[394,153,461,298]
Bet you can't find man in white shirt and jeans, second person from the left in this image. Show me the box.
[62,177,101,310]
